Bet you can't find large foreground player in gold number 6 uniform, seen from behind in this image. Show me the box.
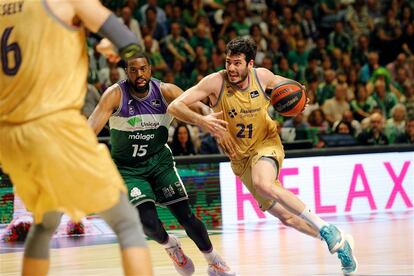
[0,0,152,275]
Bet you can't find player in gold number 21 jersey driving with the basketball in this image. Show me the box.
[168,38,357,274]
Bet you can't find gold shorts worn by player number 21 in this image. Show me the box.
[231,140,285,211]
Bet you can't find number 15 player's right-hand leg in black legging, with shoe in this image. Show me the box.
[168,200,234,276]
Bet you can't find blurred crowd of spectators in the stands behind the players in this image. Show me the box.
[84,0,414,155]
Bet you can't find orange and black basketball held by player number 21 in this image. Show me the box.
[270,80,306,117]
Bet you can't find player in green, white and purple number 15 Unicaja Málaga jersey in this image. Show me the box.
[89,55,234,276]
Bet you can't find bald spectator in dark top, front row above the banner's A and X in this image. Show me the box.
[358,113,389,145]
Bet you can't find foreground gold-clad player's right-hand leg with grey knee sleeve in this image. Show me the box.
[99,193,152,275]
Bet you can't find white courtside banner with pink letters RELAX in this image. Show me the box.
[220,152,414,225]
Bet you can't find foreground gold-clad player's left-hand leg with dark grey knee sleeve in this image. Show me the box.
[22,212,62,276]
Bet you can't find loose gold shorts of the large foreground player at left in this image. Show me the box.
[0,110,126,223]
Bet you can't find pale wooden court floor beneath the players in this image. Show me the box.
[0,210,414,276]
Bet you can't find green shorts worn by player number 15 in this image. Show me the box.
[118,146,188,206]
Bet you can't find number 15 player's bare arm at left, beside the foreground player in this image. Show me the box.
[88,85,121,134]
